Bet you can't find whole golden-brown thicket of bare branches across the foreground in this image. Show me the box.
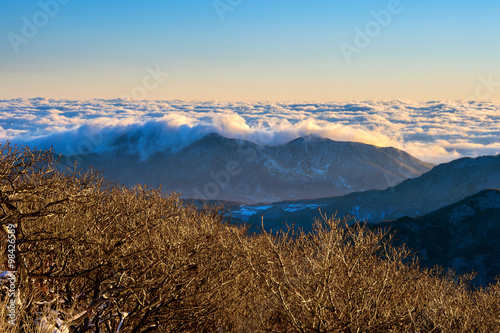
[0,144,500,333]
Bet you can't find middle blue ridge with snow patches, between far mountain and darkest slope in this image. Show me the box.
[233,155,500,229]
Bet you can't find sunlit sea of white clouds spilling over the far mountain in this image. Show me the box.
[0,98,500,163]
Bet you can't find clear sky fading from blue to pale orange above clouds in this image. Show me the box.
[0,0,500,101]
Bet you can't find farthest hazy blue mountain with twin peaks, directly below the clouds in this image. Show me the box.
[65,134,433,203]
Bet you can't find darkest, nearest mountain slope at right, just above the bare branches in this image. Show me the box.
[377,189,500,285]
